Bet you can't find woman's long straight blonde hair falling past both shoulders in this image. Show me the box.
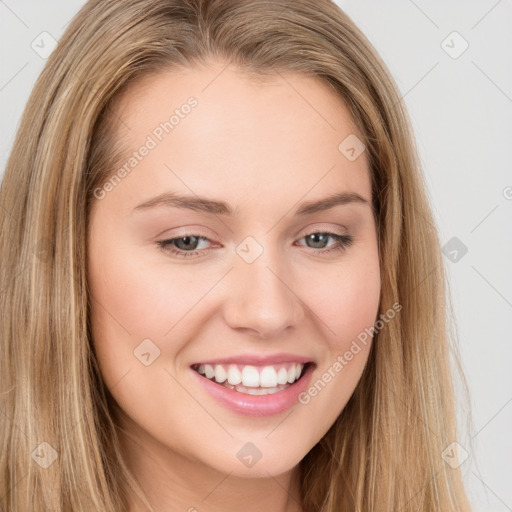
[0,0,469,512]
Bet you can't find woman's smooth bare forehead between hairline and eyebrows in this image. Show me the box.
[99,63,371,216]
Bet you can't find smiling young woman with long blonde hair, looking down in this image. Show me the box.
[0,0,469,512]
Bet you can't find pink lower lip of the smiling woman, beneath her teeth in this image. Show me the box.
[192,363,315,416]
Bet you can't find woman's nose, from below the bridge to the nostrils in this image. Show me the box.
[224,245,304,339]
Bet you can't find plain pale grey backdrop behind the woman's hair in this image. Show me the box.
[0,0,512,512]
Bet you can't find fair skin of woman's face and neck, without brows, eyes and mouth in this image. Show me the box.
[88,61,380,512]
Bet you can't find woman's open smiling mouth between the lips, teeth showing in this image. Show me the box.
[192,362,313,395]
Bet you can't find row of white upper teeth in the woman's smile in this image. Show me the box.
[197,363,304,386]
